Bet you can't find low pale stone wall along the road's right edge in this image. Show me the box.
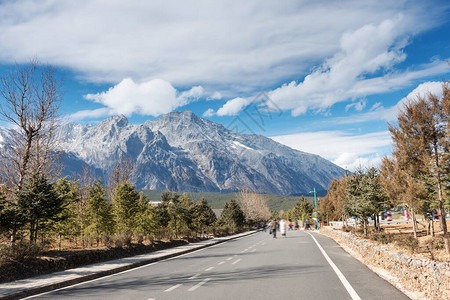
[320,228,450,300]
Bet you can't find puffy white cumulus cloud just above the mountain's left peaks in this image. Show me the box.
[75,78,205,120]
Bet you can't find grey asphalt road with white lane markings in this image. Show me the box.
[26,231,409,300]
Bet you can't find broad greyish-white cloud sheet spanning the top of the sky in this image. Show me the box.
[0,0,446,92]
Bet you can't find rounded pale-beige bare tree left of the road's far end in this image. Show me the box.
[238,189,271,221]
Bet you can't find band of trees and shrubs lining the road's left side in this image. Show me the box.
[0,61,270,281]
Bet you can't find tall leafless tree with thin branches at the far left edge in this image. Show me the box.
[0,61,62,191]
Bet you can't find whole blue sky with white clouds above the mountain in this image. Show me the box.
[0,0,450,170]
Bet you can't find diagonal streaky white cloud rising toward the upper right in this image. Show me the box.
[268,15,420,116]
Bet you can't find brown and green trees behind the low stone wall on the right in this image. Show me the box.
[318,81,450,260]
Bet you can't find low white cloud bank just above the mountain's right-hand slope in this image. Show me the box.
[271,131,391,171]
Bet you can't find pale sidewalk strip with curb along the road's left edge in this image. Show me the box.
[0,230,258,299]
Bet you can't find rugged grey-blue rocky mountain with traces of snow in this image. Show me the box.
[60,110,344,195]
